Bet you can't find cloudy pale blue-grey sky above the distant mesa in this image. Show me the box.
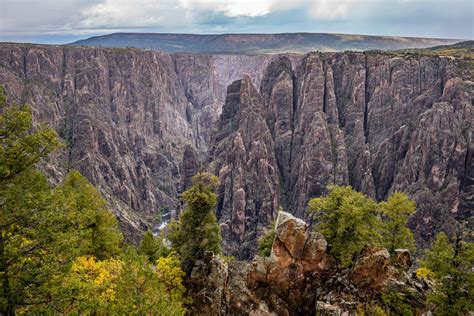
[0,0,474,43]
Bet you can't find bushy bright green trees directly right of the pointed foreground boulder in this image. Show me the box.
[308,186,415,267]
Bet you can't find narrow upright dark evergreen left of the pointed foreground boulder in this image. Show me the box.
[168,173,221,273]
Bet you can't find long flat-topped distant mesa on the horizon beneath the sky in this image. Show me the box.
[70,33,460,54]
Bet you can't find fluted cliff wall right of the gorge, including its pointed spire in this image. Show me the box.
[210,53,474,258]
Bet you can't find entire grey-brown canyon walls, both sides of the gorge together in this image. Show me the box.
[0,44,474,252]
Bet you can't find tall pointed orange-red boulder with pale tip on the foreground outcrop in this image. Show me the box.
[248,212,334,311]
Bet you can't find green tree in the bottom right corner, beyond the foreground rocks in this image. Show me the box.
[421,230,474,315]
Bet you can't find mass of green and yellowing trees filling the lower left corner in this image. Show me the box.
[0,89,186,315]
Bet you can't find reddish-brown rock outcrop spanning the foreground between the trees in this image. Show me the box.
[189,212,429,315]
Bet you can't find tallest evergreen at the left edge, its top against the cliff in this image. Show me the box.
[0,87,60,315]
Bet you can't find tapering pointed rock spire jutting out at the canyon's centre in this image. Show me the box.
[210,77,280,259]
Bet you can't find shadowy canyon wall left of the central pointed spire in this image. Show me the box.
[0,44,265,240]
